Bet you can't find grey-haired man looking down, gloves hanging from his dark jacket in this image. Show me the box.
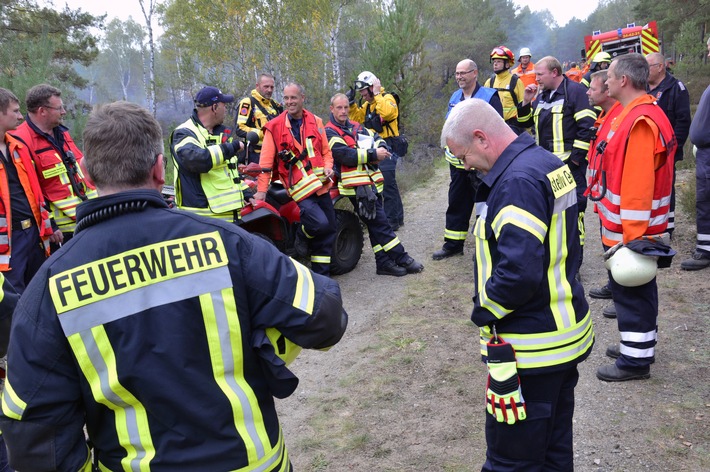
[441,98,594,472]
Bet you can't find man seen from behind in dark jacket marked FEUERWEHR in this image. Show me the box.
[0,102,347,472]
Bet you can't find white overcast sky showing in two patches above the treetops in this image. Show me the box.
[54,0,599,30]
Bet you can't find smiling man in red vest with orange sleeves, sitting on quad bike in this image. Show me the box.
[254,83,335,275]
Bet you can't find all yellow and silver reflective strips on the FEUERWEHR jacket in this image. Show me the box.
[46,232,298,471]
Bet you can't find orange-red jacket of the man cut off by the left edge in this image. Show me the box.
[0,134,54,271]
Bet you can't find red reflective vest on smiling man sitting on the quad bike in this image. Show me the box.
[262,110,332,202]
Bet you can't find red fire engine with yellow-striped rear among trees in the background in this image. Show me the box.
[582,21,660,63]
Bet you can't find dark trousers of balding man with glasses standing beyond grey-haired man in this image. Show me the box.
[444,164,476,252]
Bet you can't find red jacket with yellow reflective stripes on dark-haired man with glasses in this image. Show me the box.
[12,121,98,232]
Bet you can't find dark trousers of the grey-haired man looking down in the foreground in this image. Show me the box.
[481,366,579,472]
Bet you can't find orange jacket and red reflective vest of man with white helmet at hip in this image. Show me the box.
[590,95,677,246]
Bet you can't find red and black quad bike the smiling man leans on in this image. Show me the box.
[240,140,363,275]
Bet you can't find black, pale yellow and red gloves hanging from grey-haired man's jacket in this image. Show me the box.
[486,338,527,424]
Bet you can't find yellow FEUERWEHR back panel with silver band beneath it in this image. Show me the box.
[49,231,232,336]
